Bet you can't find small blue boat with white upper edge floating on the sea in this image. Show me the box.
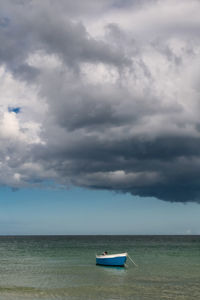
[96,252,128,267]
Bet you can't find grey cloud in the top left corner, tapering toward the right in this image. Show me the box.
[0,1,130,73]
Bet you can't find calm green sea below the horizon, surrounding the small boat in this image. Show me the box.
[0,235,200,300]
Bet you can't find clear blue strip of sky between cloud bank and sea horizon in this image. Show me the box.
[0,187,200,234]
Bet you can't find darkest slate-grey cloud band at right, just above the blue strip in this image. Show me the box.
[31,130,200,202]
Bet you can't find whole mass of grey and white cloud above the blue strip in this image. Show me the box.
[0,0,200,202]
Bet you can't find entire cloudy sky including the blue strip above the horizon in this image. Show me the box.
[0,0,200,235]
